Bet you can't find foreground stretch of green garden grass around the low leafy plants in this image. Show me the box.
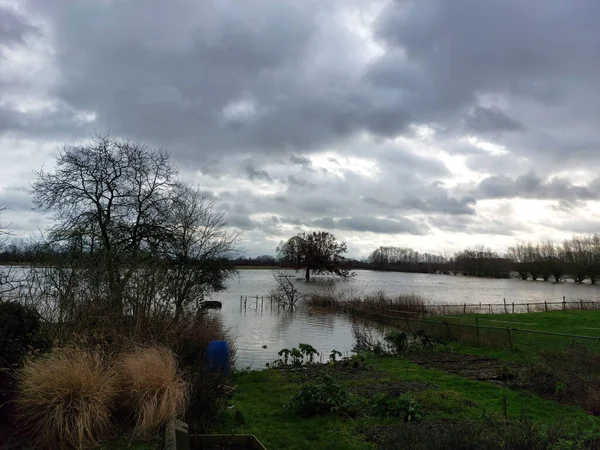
[218,354,600,450]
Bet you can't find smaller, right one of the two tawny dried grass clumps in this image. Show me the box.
[120,347,188,436]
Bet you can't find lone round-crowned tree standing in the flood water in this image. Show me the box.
[277,231,352,281]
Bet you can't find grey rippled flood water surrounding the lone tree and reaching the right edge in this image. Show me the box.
[212,269,600,369]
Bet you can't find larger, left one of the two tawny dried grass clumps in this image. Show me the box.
[17,348,119,448]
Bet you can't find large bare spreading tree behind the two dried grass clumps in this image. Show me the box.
[33,136,236,326]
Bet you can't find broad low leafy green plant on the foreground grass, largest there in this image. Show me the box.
[285,376,364,416]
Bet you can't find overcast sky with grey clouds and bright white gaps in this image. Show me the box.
[0,0,600,257]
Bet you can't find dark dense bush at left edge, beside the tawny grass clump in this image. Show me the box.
[0,302,50,424]
